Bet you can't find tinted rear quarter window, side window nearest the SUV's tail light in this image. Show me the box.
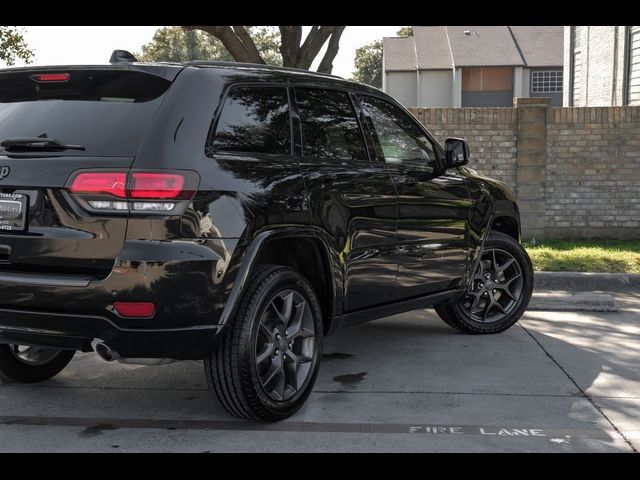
[210,86,291,154]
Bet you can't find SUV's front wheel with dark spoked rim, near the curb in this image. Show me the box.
[435,232,533,334]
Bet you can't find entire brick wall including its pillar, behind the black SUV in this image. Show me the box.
[412,99,640,239]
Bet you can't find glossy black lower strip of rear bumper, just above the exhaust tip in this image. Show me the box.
[0,309,218,360]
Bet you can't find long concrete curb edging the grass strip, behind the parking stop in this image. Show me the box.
[534,272,640,292]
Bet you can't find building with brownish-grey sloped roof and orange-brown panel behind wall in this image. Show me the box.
[383,26,563,107]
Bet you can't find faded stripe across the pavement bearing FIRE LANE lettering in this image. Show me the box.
[0,416,618,443]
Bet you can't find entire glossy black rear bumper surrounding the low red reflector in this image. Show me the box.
[0,240,241,359]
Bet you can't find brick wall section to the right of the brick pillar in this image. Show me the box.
[545,107,640,238]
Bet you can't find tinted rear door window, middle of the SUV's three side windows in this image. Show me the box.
[296,88,368,160]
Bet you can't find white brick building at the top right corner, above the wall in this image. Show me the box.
[563,25,640,107]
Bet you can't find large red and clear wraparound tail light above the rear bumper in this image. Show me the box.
[67,170,199,214]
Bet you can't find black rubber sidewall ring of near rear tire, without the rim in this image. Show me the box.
[240,269,323,416]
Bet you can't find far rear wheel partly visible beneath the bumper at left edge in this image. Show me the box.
[0,345,76,383]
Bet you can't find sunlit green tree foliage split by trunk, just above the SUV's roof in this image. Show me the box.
[135,27,282,65]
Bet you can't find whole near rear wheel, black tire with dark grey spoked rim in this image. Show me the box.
[204,265,323,422]
